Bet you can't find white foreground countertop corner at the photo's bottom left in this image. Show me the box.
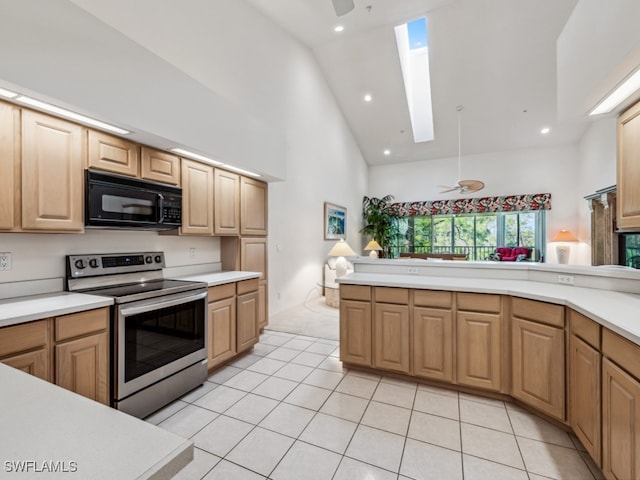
[0,364,193,480]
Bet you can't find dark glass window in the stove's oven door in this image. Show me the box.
[124,301,206,382]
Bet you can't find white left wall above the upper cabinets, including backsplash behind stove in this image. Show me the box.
[0,0,367,313]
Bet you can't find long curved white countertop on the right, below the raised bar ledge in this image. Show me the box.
[336,273,640,345]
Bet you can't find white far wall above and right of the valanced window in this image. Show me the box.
[369,146,601,263]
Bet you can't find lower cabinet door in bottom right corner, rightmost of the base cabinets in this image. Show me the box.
[602,358,640,480]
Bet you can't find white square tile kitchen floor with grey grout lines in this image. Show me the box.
[147,330,602,480]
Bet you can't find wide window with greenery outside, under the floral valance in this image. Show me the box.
[392,210,545,260]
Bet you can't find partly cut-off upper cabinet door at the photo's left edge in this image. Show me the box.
[0,103,20,230]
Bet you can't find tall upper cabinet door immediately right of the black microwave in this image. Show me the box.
[180,158,213,235]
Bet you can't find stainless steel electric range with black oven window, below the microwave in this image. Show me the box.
[66,252,207,418]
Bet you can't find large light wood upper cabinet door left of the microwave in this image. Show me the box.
[22,110,85,232]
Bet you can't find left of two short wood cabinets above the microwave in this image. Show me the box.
[88,130,140,177]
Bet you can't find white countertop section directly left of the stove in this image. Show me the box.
[0,292,113,327]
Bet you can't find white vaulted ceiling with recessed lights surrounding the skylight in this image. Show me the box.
[246,0,588,165]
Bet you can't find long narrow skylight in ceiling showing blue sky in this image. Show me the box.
[395,17,434,143]
